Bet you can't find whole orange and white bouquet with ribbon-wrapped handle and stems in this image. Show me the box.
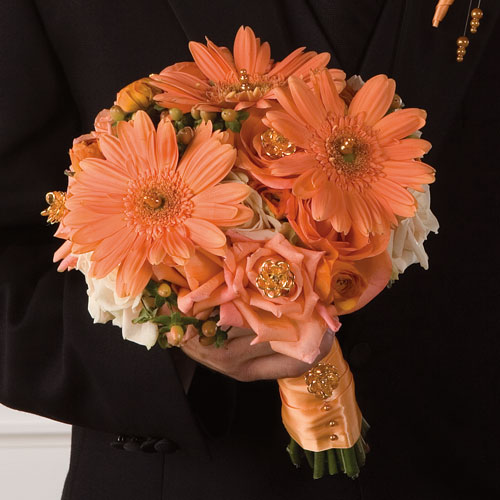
[42,27,437,478]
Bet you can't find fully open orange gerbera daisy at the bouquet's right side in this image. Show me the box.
[265,71,434,235]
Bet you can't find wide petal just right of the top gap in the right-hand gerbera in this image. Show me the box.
[348,75,394,130]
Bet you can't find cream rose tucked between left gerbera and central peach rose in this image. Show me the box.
[225,171,281,239]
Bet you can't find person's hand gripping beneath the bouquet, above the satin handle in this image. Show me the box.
[182,327,333,382]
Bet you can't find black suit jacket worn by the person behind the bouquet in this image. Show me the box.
[0,0,500,500]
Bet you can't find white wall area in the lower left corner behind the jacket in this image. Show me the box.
[0,404,71,500]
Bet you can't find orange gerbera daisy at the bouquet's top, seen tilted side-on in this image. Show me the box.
[151,26,345,112]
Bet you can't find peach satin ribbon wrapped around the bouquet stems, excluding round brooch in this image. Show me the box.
[278,338,362,451]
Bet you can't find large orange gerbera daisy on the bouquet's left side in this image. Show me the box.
[64,111,253,296]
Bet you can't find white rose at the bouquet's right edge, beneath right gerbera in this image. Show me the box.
[387,186,439,279]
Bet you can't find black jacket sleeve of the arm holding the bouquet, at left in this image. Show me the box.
[0,0,207,456]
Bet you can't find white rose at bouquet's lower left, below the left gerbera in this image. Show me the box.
[76,253,158,349]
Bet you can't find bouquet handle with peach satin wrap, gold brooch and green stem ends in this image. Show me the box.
[278,339,369,479]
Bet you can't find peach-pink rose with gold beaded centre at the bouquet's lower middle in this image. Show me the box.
[178,231,340,363]
